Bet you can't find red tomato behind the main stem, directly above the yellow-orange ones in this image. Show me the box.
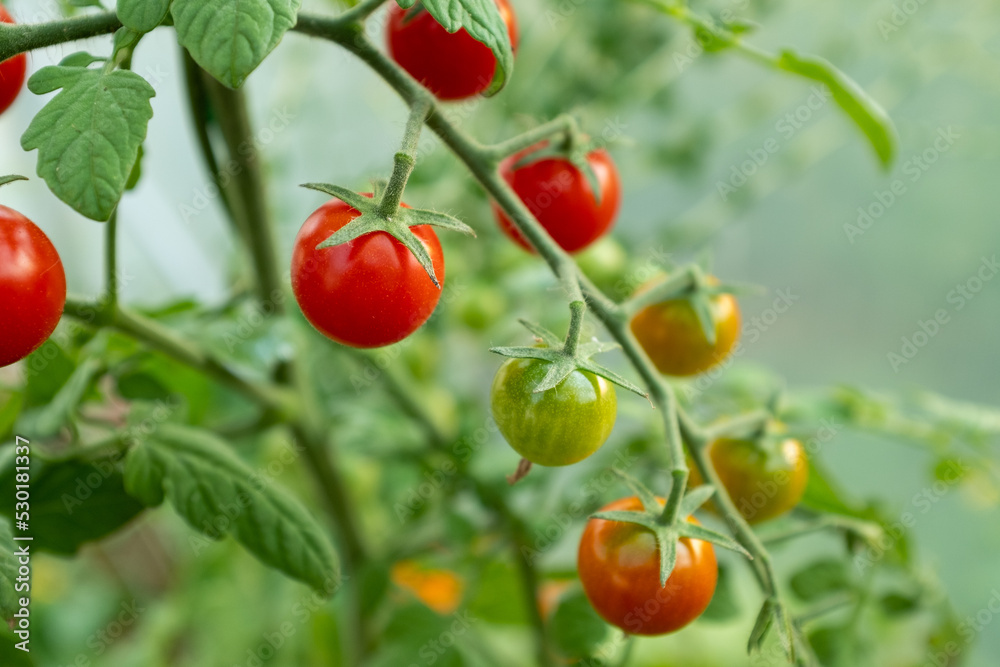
[493,148,622,253]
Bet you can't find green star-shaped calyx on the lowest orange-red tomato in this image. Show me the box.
[590,469,753,586]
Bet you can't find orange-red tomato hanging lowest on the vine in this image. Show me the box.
[577,496,719,635]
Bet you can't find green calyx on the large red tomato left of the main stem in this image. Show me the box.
[302,183,476,289]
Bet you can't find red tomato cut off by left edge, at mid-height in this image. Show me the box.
[0,206,66,367]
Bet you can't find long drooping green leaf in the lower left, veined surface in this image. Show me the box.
[125,423,340,591]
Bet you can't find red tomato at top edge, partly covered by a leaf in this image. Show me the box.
[387,0,518,100]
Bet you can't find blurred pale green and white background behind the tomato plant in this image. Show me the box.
[0,0,1000,667]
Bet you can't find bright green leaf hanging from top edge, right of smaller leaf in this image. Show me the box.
[170,0,302,88]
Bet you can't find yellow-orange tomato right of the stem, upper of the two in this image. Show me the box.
[632,283,740,375]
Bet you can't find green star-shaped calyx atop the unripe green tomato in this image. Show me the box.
[490,314,649,398]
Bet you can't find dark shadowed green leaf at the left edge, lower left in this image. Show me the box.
[0,450,143,555]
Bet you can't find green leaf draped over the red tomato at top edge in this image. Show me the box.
[416,0,514,96]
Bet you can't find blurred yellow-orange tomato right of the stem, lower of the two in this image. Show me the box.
[690,438,809,523]
